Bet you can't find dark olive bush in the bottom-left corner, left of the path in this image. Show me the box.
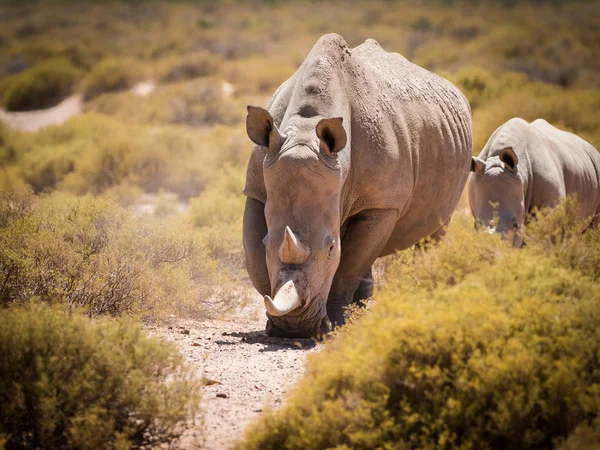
[0,304,200,450]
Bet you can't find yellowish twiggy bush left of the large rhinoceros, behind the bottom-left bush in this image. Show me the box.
[0,194,230,318]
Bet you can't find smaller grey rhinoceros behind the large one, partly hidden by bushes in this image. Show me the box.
[469,118,600,247]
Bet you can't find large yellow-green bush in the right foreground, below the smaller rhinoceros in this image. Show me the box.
[238,207,600,449]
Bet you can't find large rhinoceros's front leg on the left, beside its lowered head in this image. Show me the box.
[243,198,271,295]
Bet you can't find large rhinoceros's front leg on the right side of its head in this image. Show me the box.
[327,209,398,325]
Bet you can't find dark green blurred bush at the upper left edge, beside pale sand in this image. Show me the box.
[0,59,80,111]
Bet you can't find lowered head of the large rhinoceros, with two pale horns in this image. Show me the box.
[246,107,346,337]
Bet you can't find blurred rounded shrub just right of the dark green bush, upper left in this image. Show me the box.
[83,59,141,100]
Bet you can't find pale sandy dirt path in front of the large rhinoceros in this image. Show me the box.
[154,298,318,449]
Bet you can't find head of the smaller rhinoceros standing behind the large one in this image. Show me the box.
[469,147,525,247]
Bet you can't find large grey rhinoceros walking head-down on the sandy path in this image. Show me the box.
[243,34,472,337]
